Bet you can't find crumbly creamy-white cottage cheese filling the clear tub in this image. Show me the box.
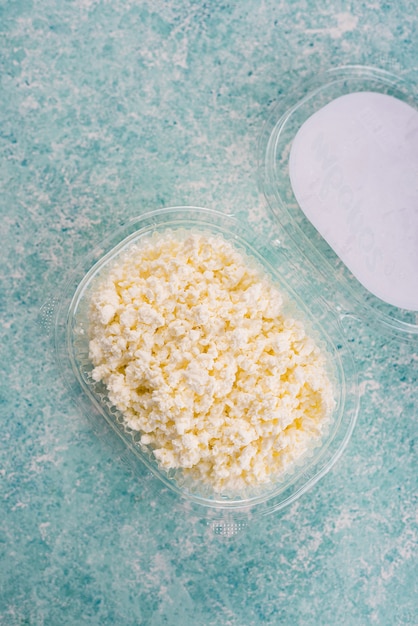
[89,231,334,493]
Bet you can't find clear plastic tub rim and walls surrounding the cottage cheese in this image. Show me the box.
[55,207,358,512]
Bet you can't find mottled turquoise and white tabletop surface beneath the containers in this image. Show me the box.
[0,0,418,626]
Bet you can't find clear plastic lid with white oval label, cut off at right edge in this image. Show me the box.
[260,66,418,339]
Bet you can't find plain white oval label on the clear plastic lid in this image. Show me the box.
[289,91,418,311]
